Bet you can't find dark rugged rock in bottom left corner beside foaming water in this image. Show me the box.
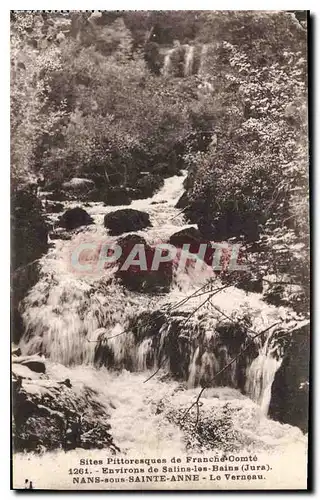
[12,363,120,452]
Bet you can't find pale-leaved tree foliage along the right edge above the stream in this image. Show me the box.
[182,14,309,312]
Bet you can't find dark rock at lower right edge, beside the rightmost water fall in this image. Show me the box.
[269,326,310,432]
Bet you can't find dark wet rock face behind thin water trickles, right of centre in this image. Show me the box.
[158,311,258,390]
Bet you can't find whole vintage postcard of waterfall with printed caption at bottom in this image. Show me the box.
[10,10,310,492]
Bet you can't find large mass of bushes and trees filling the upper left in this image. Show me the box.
[12,13,194,191]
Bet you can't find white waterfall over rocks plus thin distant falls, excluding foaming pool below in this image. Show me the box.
[20,168,292,412]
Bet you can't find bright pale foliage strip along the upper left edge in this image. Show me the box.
[11,12,65,185]
